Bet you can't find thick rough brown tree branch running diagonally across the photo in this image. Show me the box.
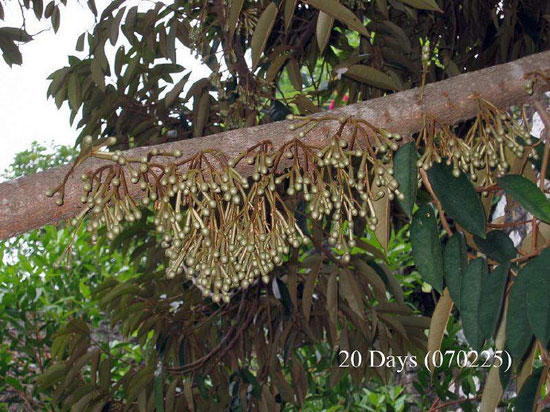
[0,52,550,239]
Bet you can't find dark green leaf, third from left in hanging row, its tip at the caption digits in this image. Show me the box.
[460,258,487,351]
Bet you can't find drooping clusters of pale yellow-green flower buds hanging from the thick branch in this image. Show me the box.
[48,101,536,302]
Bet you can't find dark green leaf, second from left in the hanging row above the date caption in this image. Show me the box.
[443,232,468,309]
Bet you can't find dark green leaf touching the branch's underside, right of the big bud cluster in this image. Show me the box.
[393,142,418,219]
